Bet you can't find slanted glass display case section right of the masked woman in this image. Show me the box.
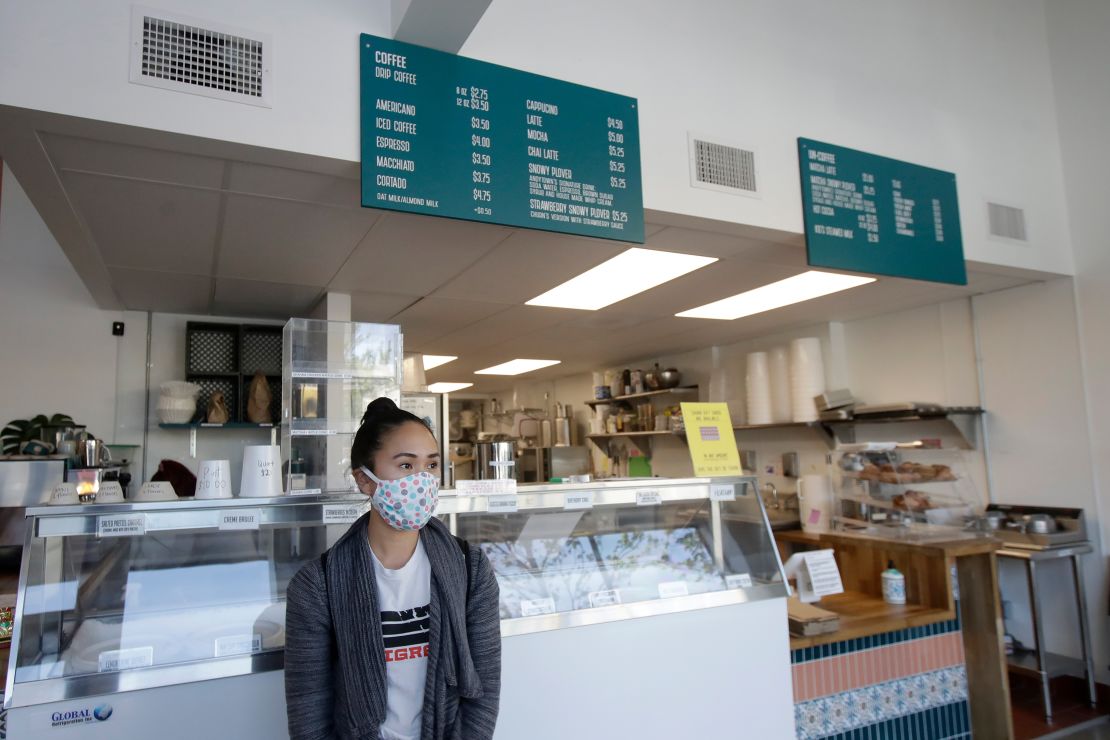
[441,477,786,635]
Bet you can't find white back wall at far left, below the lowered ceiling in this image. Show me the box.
[0,163,286,488]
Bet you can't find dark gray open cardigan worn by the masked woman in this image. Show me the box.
[285,514,501,740]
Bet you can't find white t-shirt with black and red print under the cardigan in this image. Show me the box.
[367,540,432,740]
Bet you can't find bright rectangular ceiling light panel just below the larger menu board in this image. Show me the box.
[527,246,717,311]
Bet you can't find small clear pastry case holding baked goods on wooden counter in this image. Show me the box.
[830,443,982,538]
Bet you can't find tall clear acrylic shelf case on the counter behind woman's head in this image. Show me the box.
[281,318,402,494]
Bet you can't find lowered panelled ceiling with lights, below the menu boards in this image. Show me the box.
[0,107,1038,391]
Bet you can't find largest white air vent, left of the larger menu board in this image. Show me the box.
[131,6,271,108]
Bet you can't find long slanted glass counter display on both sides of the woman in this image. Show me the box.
[6,478,786,708]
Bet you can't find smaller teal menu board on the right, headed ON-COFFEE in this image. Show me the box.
[798,139,968,285]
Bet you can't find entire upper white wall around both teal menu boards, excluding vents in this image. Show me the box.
[0,0,1072,274]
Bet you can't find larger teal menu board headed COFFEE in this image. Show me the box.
[360,34,644,243]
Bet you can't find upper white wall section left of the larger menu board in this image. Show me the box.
[0,0,390,161]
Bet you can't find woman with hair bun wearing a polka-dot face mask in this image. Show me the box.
[285,398,501,740]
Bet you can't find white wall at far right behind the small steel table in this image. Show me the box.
[975,278,1108,680]
